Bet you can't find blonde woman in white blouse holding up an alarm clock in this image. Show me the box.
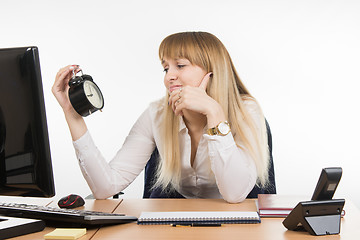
[52,32,269,203]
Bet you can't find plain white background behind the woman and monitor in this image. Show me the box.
[0,0,360,207]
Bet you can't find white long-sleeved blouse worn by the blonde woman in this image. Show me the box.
[73,97,263,203]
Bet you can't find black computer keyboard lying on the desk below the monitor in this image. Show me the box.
[0,202,137,227]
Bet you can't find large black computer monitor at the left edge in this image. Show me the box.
[0,47,55,197]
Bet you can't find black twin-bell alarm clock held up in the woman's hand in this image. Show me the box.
[69,70,104,117]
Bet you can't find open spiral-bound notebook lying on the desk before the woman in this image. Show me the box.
[138,211,261,225]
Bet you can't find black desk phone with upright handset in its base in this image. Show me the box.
[283,167,345,235]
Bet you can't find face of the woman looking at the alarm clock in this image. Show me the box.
[162,58,206,94]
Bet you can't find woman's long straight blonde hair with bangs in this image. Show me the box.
[154,32,269,192]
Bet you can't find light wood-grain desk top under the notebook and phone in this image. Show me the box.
[7,199,360,240]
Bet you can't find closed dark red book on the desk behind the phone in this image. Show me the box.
[256,194,345,218]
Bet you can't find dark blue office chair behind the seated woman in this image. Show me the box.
[143,119,276,198]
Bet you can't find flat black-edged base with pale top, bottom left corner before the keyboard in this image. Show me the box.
[0,216,45,239]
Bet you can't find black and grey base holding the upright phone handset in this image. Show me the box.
[283,199,345,235]
